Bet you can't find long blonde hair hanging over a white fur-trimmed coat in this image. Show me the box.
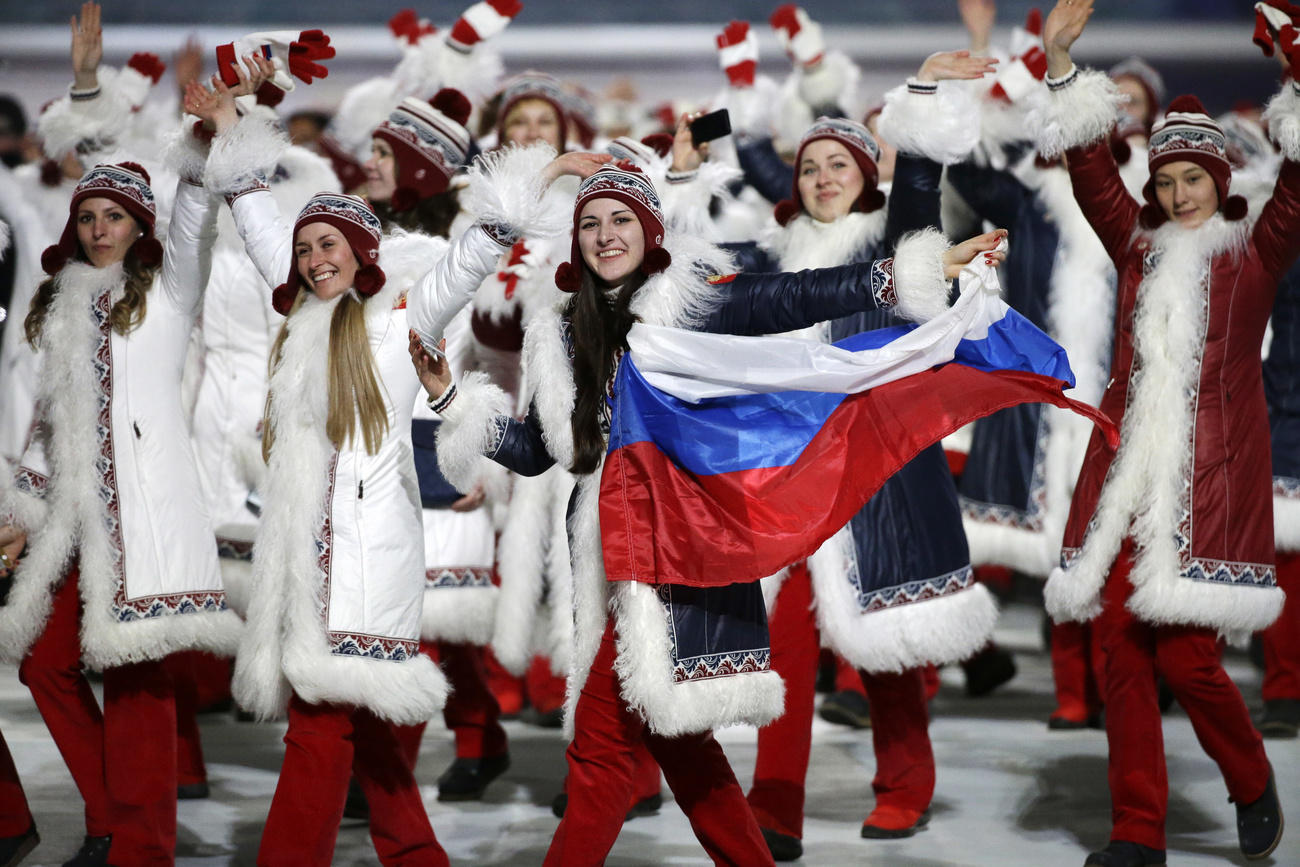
[261,291,389,460]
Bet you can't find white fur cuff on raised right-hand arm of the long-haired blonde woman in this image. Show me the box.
[462,144,573,238]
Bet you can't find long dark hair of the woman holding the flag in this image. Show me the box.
[566,269,646,474]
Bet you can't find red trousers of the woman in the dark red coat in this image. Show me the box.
[1096,553,1269,849]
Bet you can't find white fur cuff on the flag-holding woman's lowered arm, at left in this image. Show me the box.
[438,370,510,490]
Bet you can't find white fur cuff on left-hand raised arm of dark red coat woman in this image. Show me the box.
[1027,68,1125,160]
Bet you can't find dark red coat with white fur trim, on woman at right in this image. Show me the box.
[1048,142,1300,630]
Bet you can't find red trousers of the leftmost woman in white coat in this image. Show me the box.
[18,569,176,866]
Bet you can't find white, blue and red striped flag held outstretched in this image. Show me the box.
[601,254,1119,586]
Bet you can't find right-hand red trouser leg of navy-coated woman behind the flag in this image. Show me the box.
[862,668,935,828]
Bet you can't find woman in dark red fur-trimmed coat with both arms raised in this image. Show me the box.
[1037,0,1300,867]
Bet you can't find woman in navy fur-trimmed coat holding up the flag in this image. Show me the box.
[411,155,1001,864]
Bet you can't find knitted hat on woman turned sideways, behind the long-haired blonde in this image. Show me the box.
[373,87,471,211]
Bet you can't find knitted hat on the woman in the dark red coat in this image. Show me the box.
[1141,95,1245,229]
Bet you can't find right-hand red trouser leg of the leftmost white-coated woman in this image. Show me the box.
[104,660,185,864]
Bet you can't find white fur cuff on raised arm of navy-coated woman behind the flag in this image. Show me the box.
[878,81,980,165]
